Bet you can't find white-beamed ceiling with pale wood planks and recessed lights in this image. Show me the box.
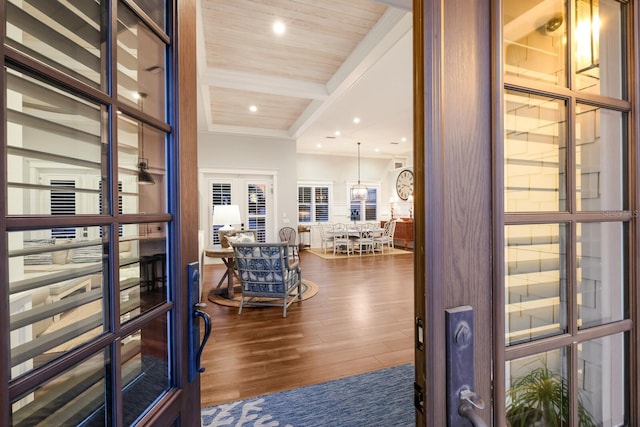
[198,0,413,157]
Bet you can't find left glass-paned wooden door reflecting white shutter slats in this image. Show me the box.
[0,0,200,426]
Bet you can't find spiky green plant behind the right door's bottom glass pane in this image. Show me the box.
[507,363,597,427]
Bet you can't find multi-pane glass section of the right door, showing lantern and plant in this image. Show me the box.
[502,0,637,426]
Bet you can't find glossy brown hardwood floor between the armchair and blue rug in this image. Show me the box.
[201,251,414,407]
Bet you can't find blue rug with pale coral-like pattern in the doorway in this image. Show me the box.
[201,365,415,427]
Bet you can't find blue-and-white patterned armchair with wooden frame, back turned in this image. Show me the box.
[233,242,302,317]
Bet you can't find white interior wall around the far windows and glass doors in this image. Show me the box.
[198,132,411,244]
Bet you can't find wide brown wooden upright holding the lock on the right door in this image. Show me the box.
[413,0,495,426]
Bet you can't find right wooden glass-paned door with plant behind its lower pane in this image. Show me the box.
[414,0,638,426]
